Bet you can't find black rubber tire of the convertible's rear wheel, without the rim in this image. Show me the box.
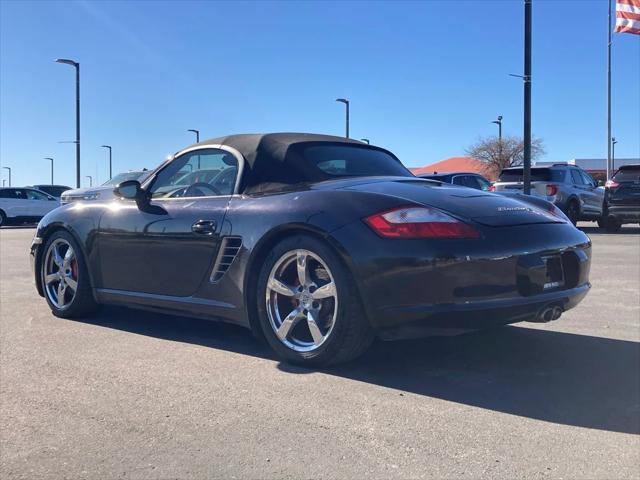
[256,235,374,367]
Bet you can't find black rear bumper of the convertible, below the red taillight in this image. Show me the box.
[334,219,591,337]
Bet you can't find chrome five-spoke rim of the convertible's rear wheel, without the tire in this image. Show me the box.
[266,249,338,352]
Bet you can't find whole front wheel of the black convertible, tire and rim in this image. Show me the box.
[40,231,97,318]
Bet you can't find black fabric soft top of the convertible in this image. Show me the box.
[191,133,399,192]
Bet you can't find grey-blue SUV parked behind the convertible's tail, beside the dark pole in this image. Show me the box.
[491,163,604,225]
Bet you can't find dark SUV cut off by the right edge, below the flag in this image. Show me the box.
[603,164,640,232]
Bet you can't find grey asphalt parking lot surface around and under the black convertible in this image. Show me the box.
[0,227,640,479]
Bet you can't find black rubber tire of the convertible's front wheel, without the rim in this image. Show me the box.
[38,230,98,318]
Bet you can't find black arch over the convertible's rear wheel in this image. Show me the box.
[244,223,362,337]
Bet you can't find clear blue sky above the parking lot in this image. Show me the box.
[0,0,640,185]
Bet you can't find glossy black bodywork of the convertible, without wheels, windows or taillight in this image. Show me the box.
[31,134,591,338]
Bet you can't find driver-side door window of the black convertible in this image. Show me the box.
[149,148,238,198]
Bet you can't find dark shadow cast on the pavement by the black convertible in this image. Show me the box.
[83,308,640,434]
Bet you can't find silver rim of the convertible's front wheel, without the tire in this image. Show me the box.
[42,238,78,309]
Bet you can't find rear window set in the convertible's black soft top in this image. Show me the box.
[302,145,413,177]
